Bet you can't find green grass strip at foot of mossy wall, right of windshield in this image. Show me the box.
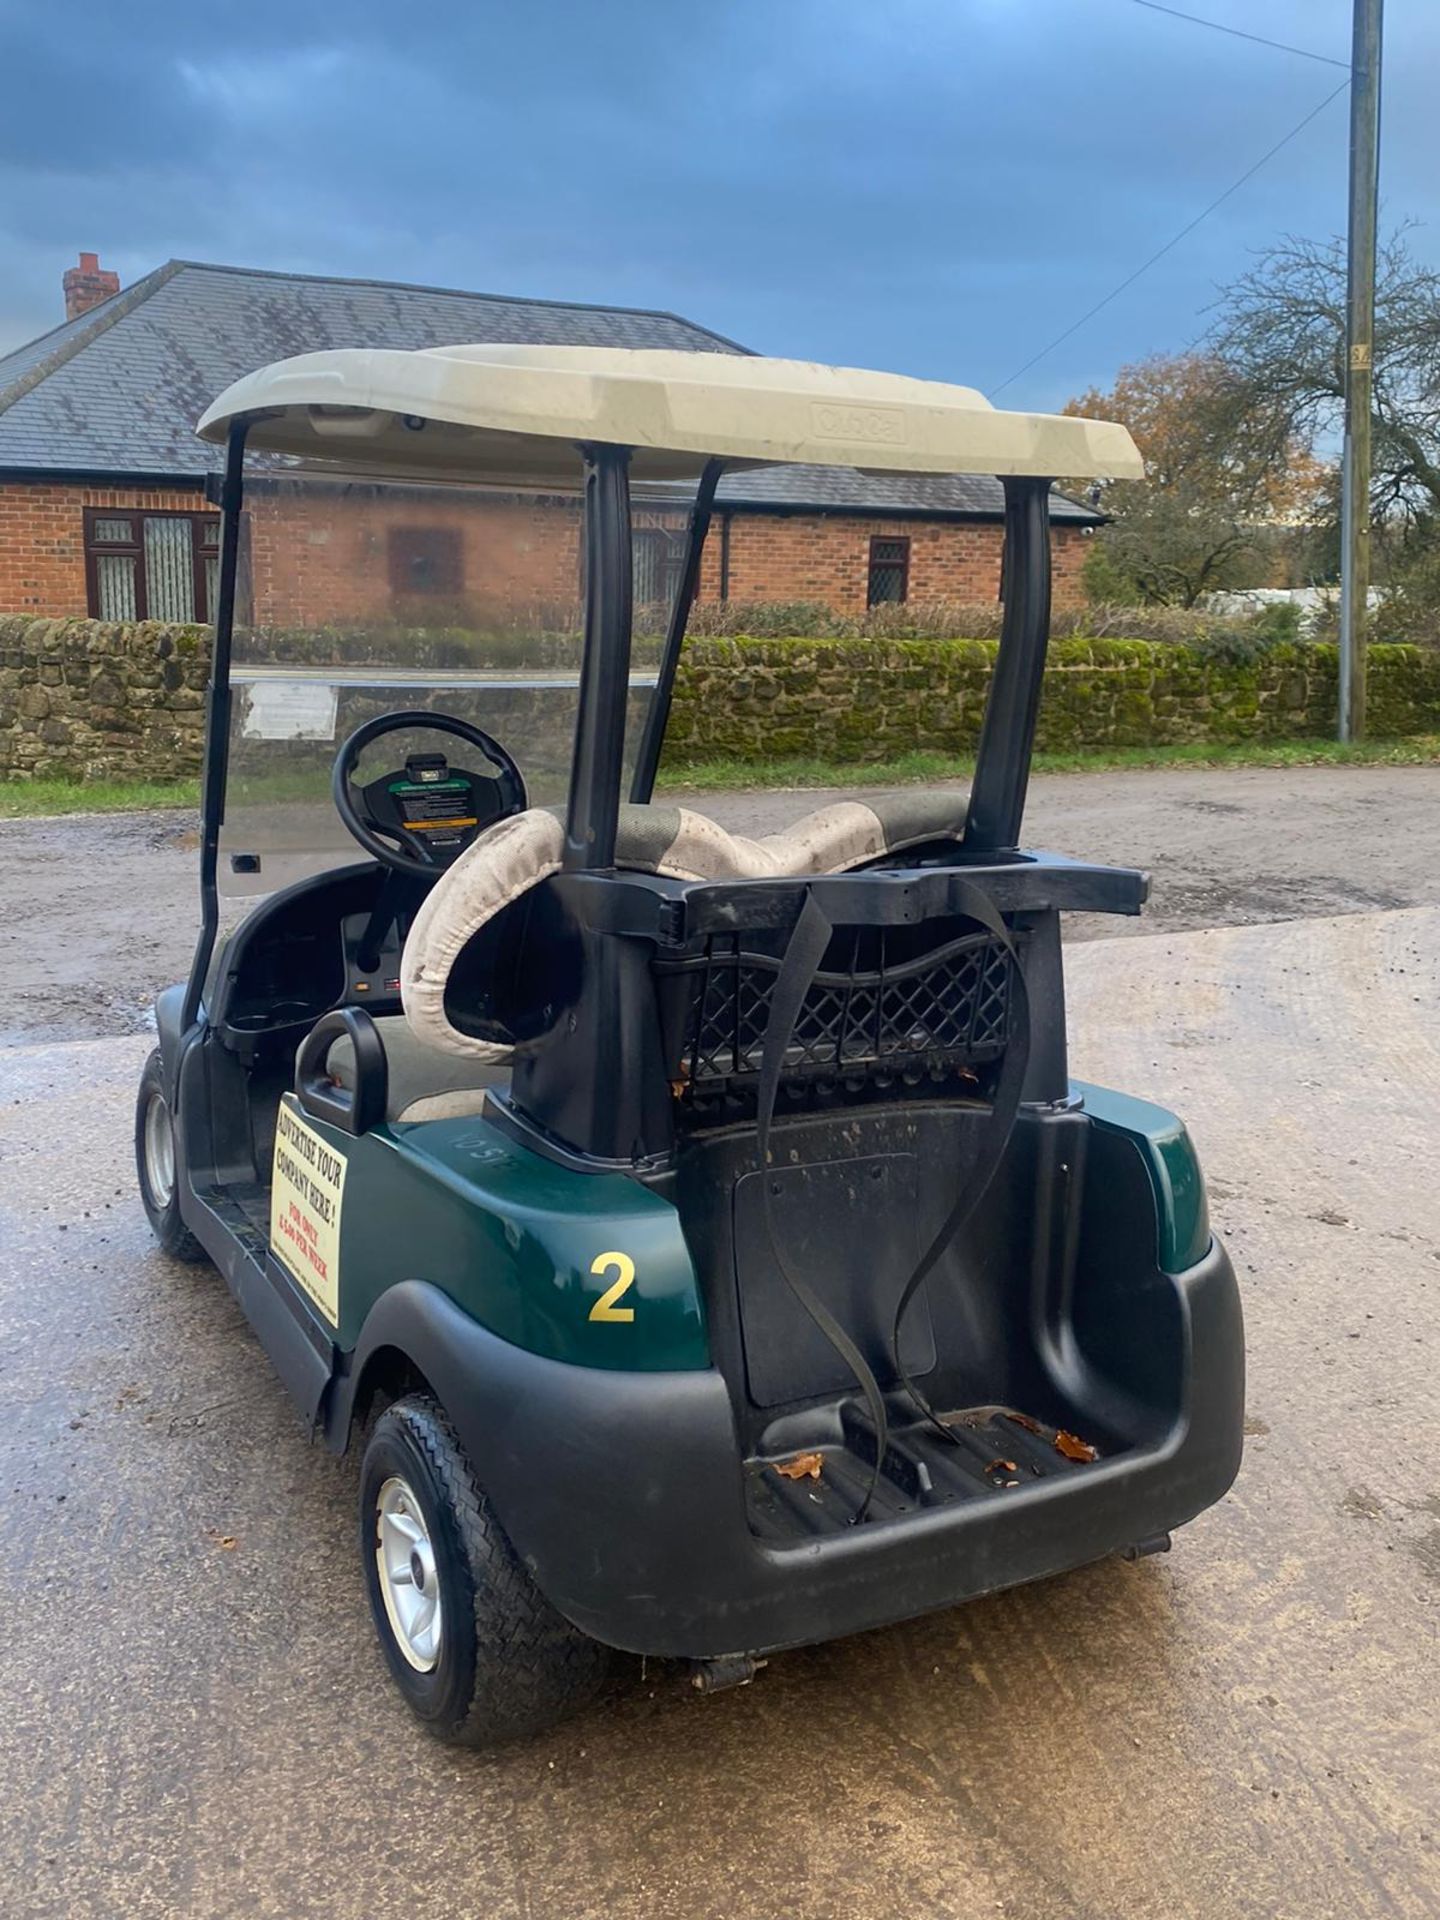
[657,733,1440,793]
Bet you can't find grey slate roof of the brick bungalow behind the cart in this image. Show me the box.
[0,259,1104,524]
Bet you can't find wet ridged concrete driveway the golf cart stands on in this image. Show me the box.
[0,776,1440,1920]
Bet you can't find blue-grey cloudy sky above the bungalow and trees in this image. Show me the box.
[0,0,1440,405]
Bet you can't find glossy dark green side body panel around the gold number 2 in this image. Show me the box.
[272,1096,710,1373]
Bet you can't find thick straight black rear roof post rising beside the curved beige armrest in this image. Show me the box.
[563,445,634,874]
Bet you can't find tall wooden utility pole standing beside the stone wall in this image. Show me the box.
[1340,0,1384,739]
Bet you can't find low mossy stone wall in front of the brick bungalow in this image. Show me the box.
[0,618,1440,780]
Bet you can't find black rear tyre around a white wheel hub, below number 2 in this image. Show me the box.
[359,1394,612,1747]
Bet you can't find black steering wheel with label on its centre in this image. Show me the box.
[330,710,528,879]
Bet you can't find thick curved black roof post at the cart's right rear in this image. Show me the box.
[966,476,1050,852]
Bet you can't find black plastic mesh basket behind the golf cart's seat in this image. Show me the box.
[657,927,1012,1089]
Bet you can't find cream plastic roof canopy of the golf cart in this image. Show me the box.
[198,346,1144,486]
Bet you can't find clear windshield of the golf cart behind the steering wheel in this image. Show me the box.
[219,455,693,895]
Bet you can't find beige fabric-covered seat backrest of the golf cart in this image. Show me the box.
[399,791,970,1068]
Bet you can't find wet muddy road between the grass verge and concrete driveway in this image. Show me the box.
[0,766,1440,1044]
